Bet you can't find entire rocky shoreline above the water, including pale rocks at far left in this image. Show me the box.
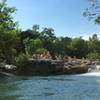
[0,59,100,75]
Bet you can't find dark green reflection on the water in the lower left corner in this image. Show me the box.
[0,76,18,100]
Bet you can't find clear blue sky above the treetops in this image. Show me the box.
[7,0,100,39]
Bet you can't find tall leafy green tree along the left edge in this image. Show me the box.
[0,0,18,63]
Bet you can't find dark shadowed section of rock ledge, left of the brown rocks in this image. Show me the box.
[17,60,63,75]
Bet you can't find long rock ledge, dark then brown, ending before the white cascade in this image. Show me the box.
[17,60,88,75]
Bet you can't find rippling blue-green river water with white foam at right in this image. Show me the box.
[0,73,100,100]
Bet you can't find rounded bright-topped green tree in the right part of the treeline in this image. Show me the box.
[69,37,88,58]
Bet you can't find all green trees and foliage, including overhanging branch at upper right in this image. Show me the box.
[0,0,100,66]
